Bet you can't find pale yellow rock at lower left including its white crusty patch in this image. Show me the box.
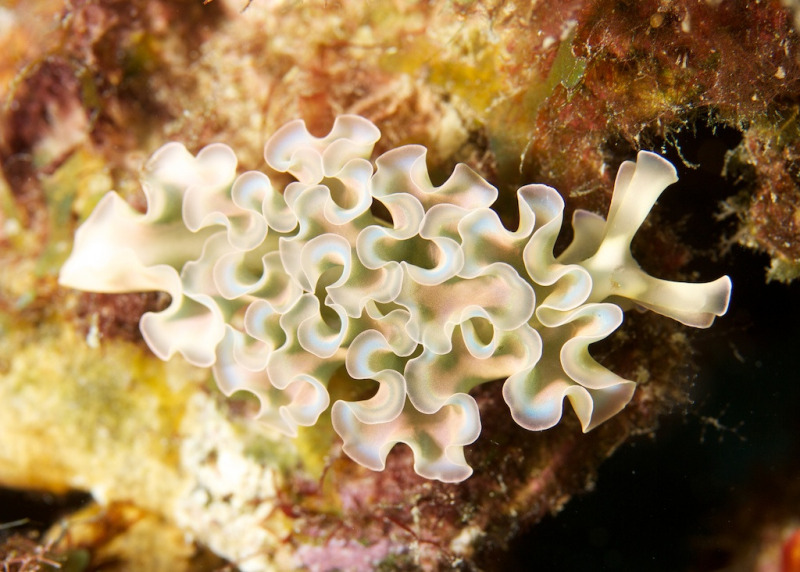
[0,323,296,570]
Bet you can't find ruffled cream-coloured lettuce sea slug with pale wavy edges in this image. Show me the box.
[60,115,731,482]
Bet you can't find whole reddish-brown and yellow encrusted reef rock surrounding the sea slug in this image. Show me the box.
[0,0,800,569]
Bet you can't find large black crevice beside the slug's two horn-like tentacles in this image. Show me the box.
[497,115,800,571]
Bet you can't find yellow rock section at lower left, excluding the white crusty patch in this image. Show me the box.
[0,325,192,500]
